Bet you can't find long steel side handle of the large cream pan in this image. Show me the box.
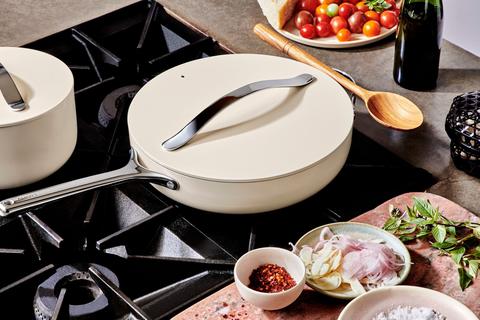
[0,149,179,217]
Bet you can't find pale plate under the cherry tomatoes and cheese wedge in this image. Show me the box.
[276,19,397,49]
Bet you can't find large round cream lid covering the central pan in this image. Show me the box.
[128,54,353,182]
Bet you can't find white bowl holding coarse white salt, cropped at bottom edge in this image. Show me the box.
[338,286,478,320]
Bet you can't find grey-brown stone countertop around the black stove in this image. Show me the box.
[0,0,480,213]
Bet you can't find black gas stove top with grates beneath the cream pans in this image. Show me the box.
[0,1,434,320]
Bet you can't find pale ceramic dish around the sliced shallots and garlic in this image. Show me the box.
[295,222,411,299]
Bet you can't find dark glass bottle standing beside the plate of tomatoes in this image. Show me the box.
[393,0,443,90]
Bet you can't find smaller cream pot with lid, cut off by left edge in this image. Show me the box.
[0,47,77,189]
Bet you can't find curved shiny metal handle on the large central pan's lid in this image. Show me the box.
[162,73,315,151]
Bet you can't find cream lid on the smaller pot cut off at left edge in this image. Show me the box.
[0,47,73,127]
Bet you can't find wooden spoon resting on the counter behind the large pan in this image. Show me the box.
[253,23,423,130]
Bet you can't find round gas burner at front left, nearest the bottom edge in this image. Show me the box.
[33,264,118,320]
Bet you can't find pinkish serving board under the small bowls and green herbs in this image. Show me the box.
[173,193,480,320]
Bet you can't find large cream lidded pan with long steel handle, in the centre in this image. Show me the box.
[0,54,353,215]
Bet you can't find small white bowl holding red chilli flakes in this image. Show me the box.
[233,247,305,310]
